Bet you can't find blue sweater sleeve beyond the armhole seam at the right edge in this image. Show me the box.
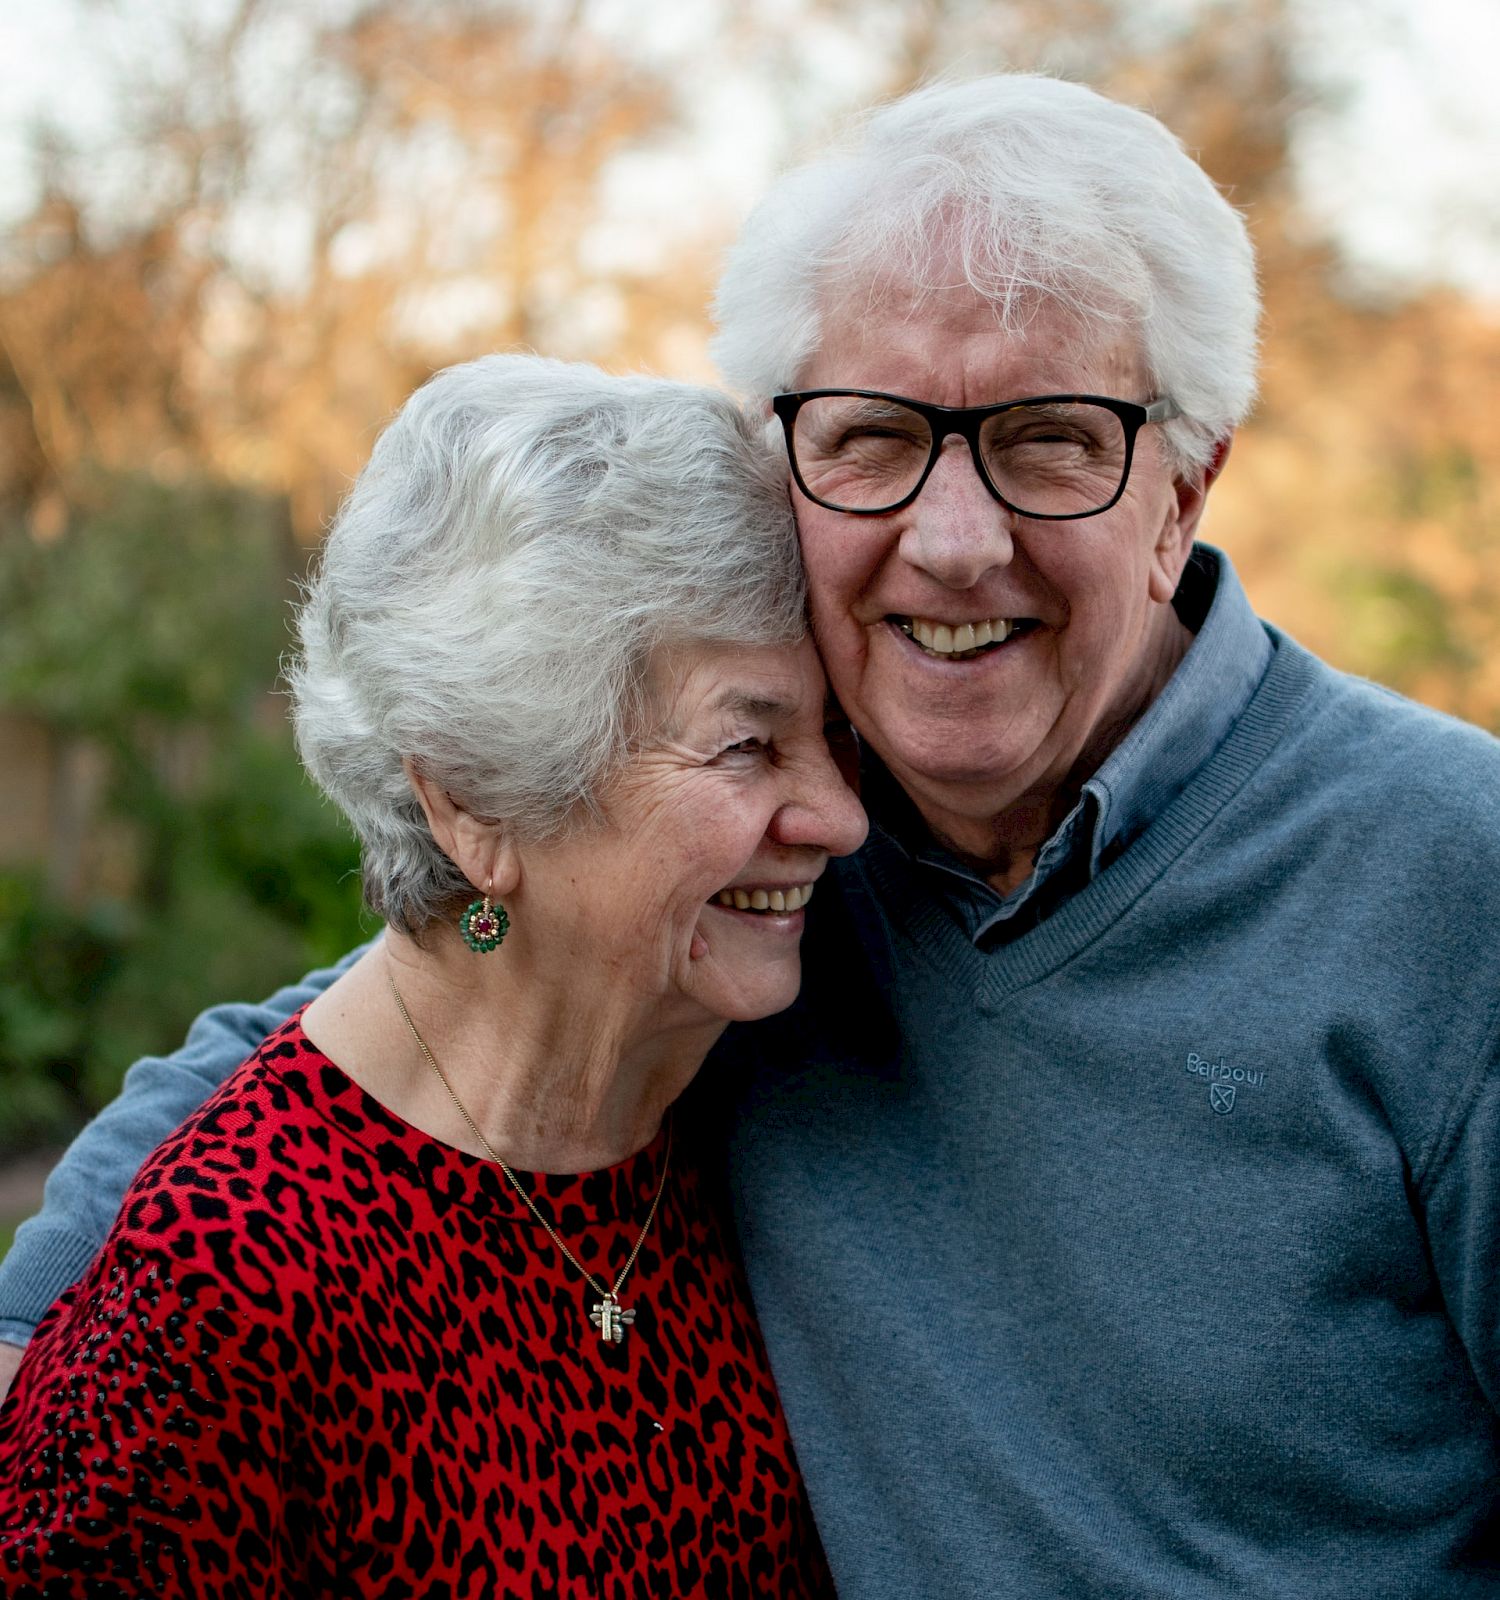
[1423,1011,1500,1413]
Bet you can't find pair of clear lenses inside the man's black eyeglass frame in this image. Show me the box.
[792,395,1127,517]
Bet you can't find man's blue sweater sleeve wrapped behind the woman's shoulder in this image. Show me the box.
[0,946,369,1344]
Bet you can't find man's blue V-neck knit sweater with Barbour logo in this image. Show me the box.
[0,592,1500,1600]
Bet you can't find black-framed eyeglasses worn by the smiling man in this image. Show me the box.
[771,389,1182,522]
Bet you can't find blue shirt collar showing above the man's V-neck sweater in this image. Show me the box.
[865,544,1273,944]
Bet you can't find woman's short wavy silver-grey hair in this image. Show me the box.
[289,355,806,931]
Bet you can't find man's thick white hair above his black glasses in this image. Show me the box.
[713,74,1260,466]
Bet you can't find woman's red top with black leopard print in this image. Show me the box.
[0,1018,832,1600]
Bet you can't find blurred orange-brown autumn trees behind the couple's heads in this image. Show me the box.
[0,0,1500,722]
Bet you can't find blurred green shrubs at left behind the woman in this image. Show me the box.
[0,478,371,1154]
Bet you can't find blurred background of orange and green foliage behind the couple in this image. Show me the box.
[0,0,1500,1162]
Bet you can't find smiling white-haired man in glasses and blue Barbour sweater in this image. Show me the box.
[0,77,1500,1600]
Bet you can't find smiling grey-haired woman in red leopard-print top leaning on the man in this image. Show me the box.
[0,357,865,1595]
